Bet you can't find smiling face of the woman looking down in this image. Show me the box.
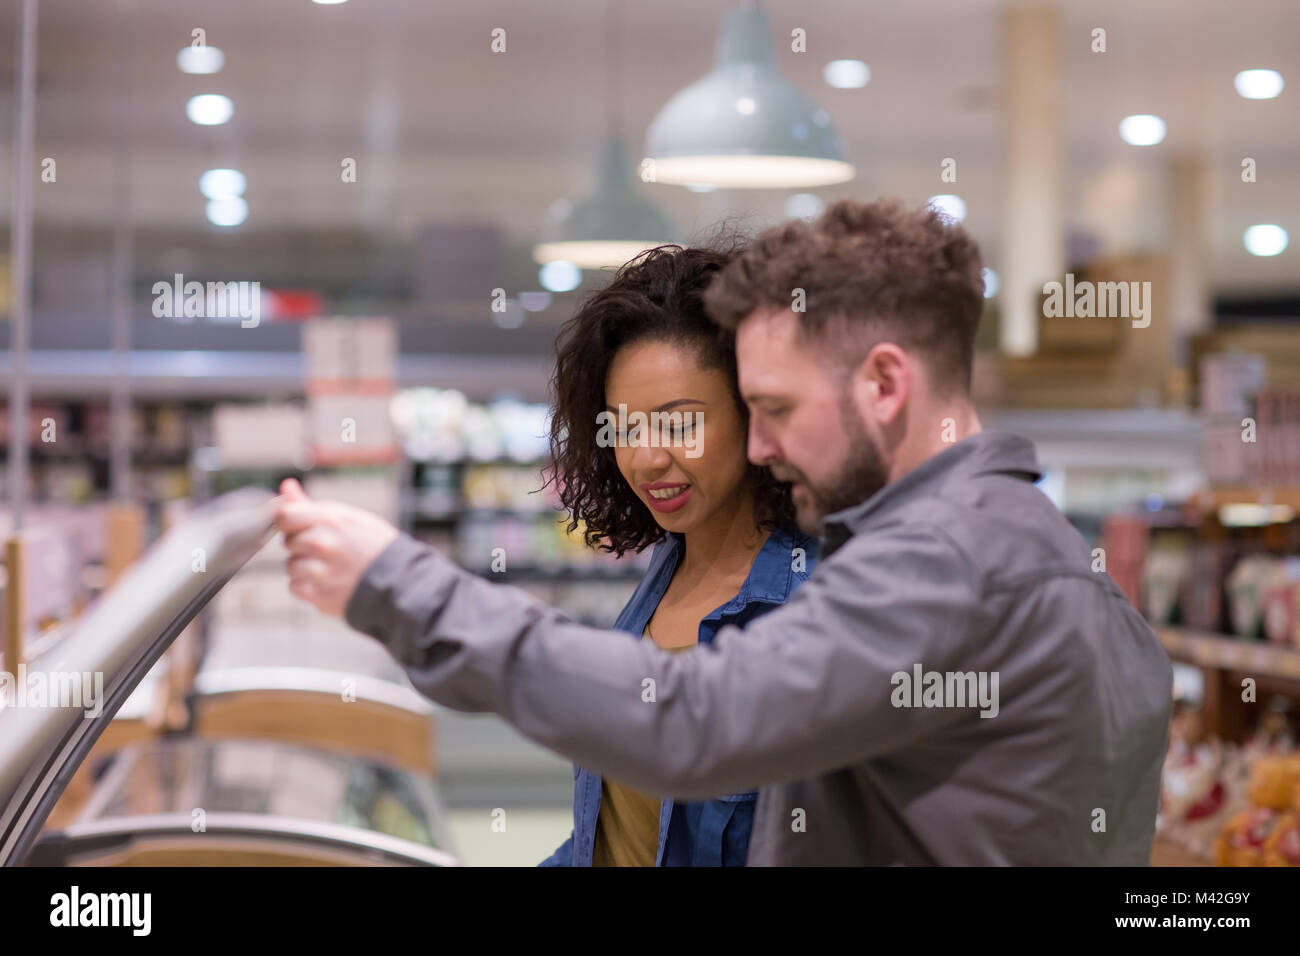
[605,341,748,533]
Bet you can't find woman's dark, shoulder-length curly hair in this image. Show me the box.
[543,238,794,557]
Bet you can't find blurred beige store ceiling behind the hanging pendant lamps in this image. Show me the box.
[0,0,1300,351]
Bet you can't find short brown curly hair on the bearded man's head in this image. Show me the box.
[705,199,984,394]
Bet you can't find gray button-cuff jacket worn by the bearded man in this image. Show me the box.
[346,432,1171,865]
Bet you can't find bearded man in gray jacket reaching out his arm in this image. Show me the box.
[277,202,1171,865]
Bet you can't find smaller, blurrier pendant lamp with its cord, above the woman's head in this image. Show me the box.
[533,0,673,269]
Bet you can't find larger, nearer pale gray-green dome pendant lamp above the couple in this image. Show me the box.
[642,3,857,189]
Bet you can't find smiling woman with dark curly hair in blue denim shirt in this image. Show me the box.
[542,246,816,866]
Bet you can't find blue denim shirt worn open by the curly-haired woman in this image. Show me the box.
[540,529,818,866]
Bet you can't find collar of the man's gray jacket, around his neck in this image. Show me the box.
[822,431,1043,558]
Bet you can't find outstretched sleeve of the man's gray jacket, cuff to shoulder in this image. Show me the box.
[345,523,979,800]
